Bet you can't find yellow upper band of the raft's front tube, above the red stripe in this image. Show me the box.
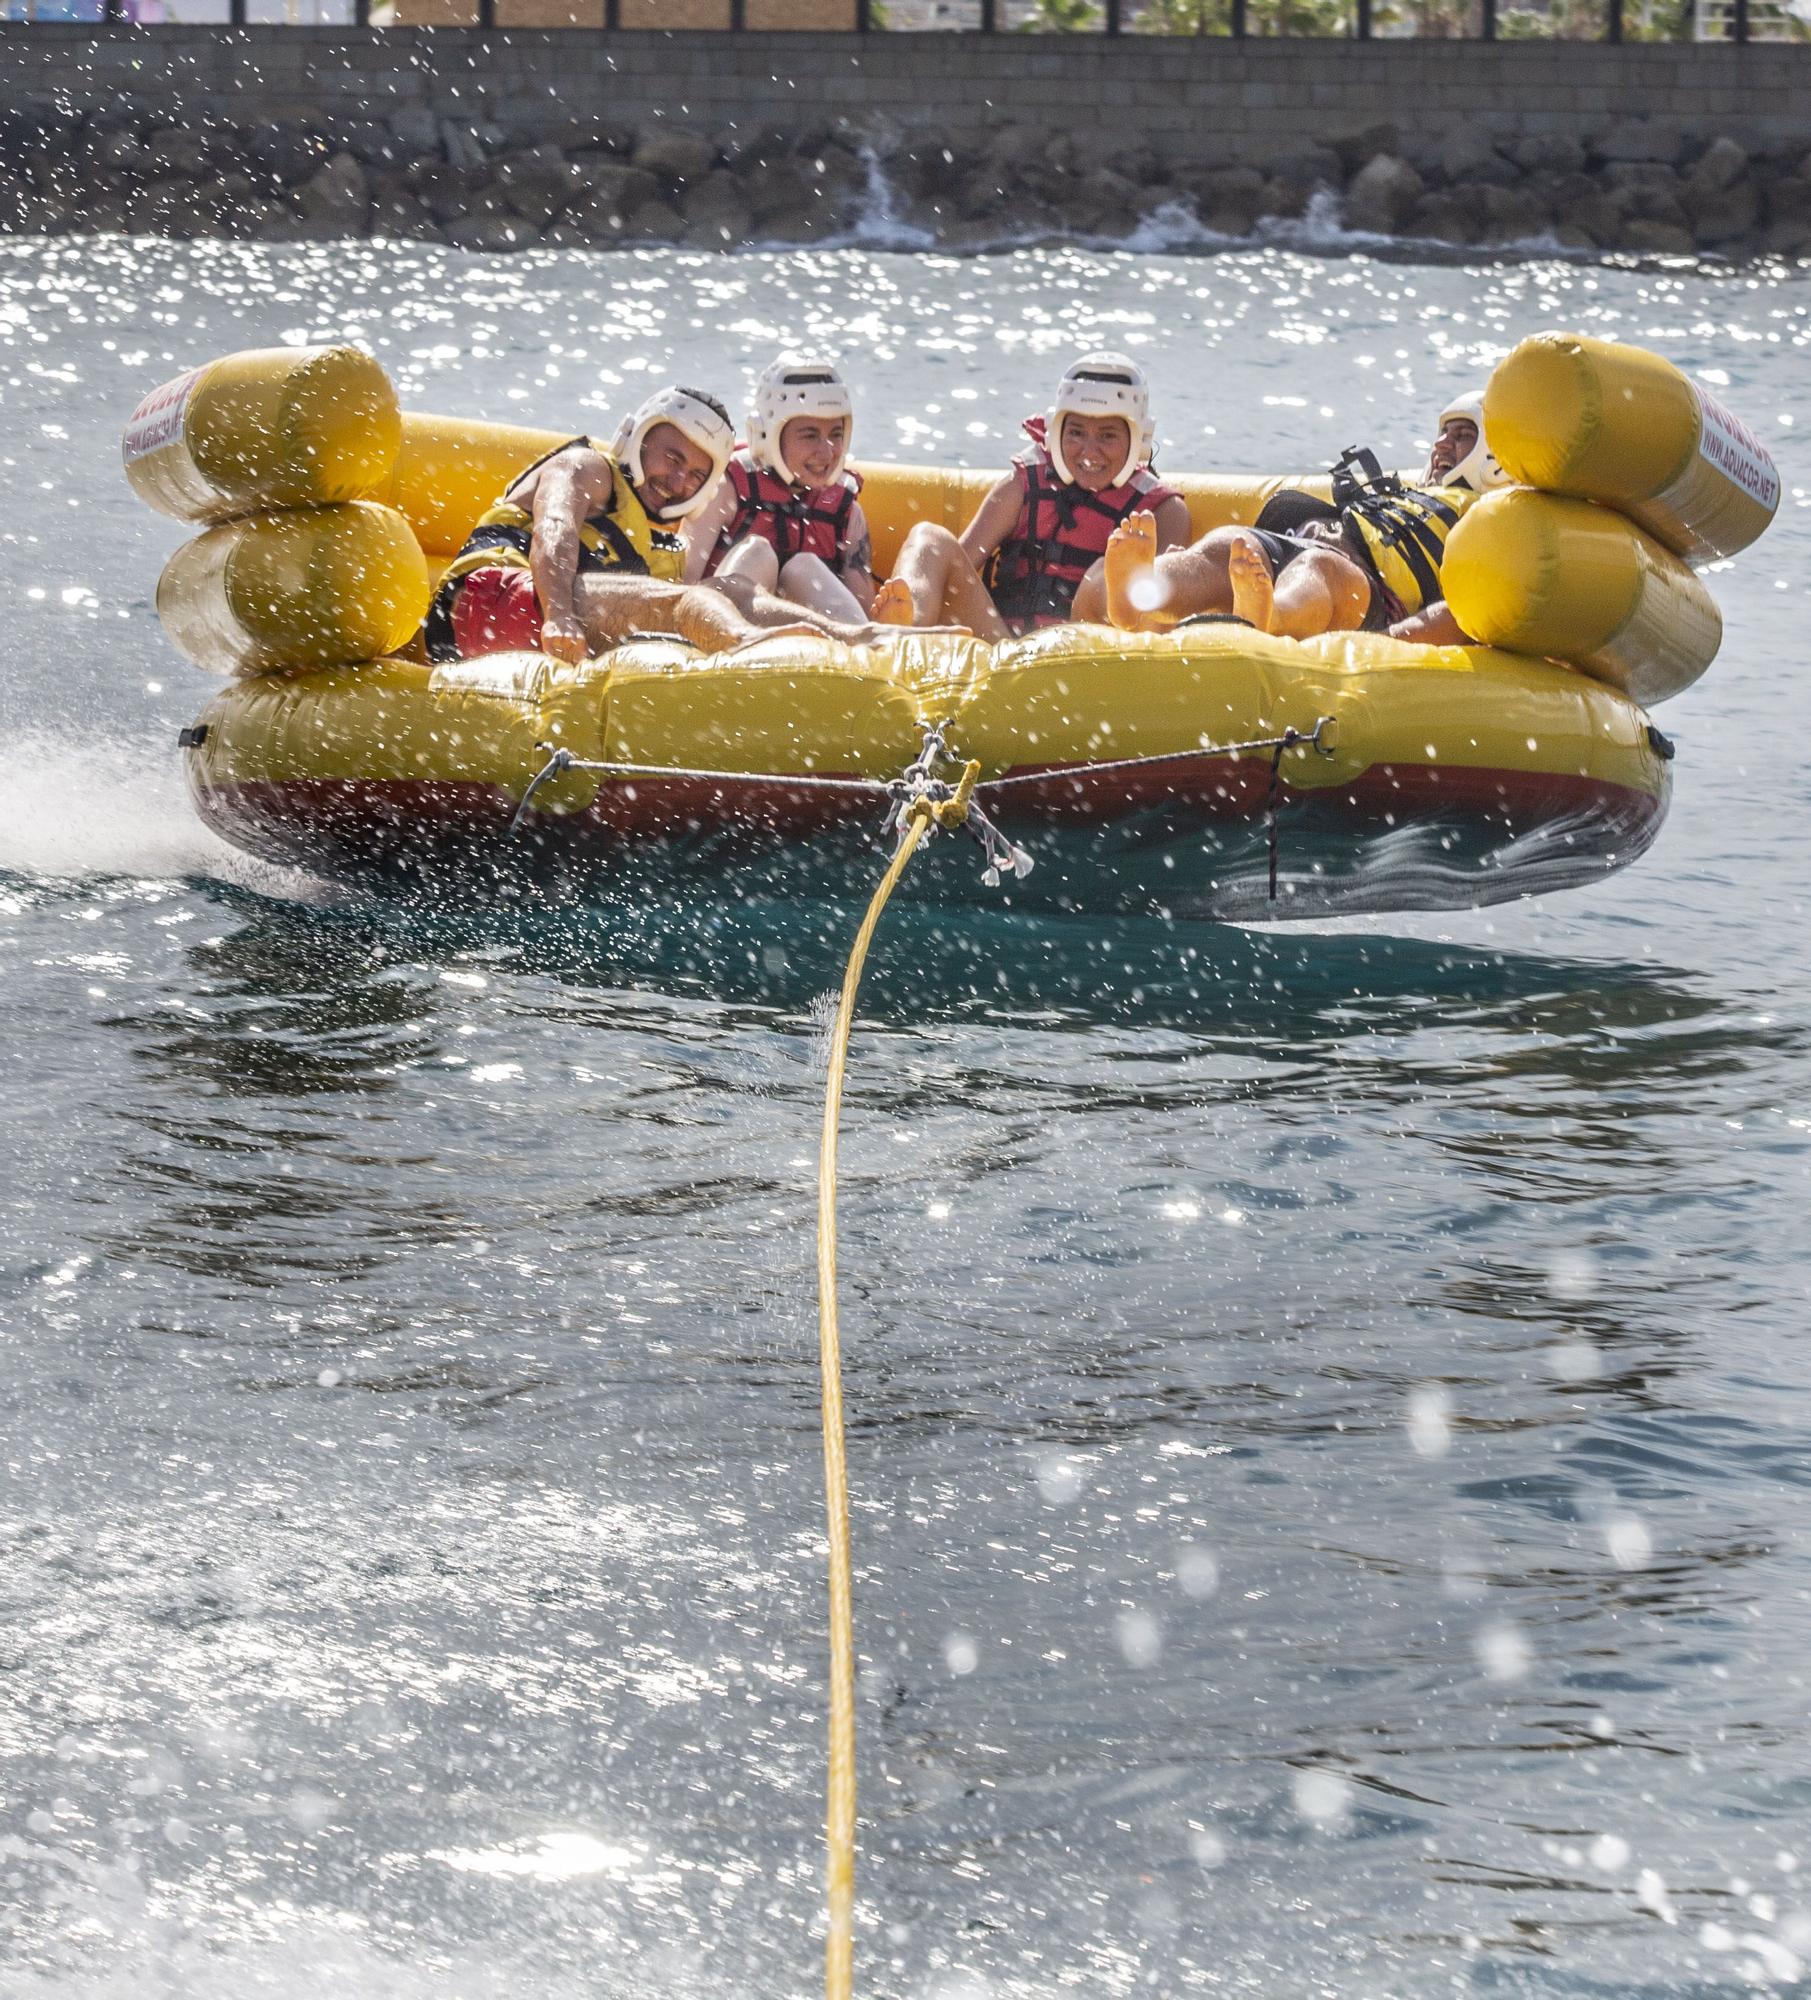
[196,628,1665,820]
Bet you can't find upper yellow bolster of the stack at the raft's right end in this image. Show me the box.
[1483,334,1779,562]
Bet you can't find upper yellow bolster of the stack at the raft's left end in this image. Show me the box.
[122,348,402,522]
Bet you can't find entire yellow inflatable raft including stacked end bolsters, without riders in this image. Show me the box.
[124,334,1779,920]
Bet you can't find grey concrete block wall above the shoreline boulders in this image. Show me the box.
[0,26,1811,164]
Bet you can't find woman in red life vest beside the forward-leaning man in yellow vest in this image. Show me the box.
[686,354,874,622]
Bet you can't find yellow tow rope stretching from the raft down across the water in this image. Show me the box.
[818,764,981,2000]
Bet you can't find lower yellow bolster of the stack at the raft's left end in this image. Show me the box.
[158,500,432,674]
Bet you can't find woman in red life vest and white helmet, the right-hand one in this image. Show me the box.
[874,354,1189,642]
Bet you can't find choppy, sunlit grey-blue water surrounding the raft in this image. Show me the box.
[0,242,1811,2000]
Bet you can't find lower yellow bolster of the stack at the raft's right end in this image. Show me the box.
[1441,486,1723,706]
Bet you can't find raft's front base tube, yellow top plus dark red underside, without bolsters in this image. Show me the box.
[188,626,1669,918]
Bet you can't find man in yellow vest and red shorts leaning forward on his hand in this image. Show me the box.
[426,386,887,662]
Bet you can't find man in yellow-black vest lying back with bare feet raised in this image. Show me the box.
[1105,392,1507,646]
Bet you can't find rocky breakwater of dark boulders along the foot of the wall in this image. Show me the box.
[0,100,1811,258]
